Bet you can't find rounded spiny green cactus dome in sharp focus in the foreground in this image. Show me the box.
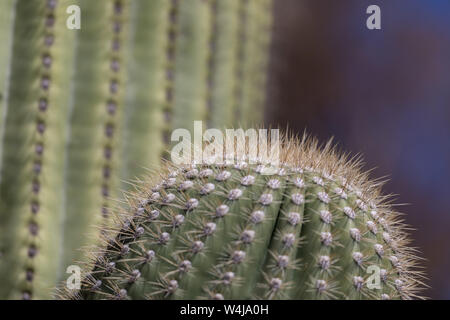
[62,140,421,299]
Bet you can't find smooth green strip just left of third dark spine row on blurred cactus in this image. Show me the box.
[122,0,171,184]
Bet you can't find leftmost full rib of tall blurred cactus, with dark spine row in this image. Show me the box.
[0,1,72,299]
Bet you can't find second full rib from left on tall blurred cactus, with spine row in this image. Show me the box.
[63,0,129,276]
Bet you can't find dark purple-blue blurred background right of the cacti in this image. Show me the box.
[265,0,450,299]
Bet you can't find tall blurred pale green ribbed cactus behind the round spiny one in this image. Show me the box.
[0,0,270,299]
